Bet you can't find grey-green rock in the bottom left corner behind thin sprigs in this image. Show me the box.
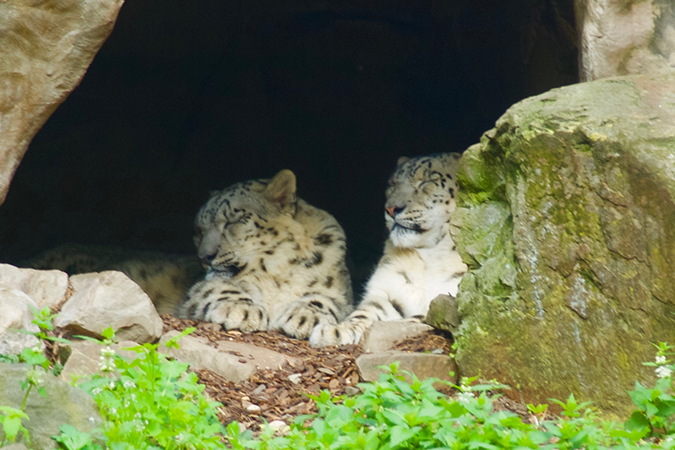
[0,363,101,449]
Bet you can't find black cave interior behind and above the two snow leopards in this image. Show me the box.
[0,0,578,288]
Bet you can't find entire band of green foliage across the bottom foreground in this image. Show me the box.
[0,310,675,450]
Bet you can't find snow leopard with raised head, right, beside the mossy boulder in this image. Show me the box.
[309,153,467,347]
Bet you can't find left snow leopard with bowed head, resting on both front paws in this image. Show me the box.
[178,170,352,339]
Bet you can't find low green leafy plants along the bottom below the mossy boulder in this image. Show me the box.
[226,358,675,450]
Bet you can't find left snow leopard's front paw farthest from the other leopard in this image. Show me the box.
[178,278,269,333]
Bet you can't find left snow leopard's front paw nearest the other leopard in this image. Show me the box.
[271,293,346,339]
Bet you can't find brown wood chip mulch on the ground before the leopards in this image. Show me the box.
[162,315,460,431]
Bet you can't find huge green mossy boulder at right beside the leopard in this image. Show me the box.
[452,72,675,416]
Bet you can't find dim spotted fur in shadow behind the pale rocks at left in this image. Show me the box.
[19,244,204,314]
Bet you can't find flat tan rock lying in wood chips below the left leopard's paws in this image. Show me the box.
[160,331,301,382]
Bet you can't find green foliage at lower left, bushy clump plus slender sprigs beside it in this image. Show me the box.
[0,308,223,450]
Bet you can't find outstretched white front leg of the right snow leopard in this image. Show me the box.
[309,289,406,347]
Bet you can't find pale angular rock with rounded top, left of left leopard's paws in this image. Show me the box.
[54,271,163,344]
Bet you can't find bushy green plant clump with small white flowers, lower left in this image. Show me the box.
[78,328,227,449]
